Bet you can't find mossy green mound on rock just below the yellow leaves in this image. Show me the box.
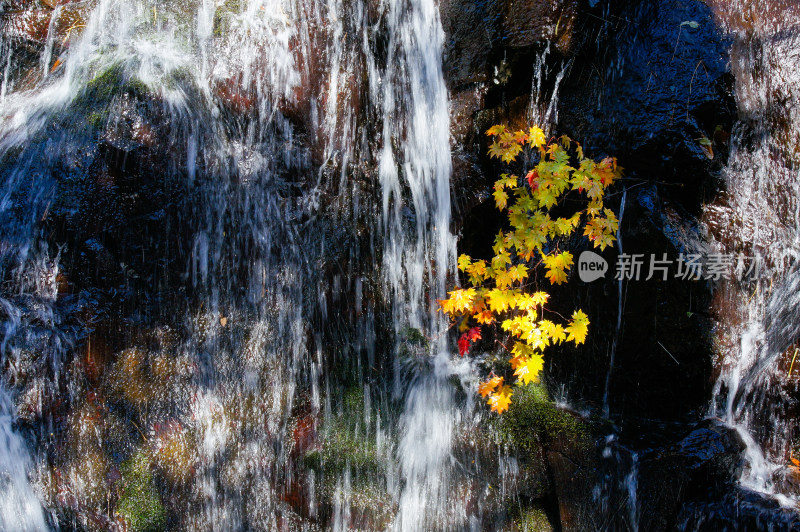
[498,383,590,453]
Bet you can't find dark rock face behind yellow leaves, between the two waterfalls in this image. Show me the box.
[443,0,736,420]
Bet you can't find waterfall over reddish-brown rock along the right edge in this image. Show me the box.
[705,2,800,506]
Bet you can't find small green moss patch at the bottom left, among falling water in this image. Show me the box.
[117,451,166,532]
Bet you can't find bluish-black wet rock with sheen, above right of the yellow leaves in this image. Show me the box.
[559,0,736,215]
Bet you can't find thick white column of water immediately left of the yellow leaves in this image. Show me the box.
[379,0,466,531]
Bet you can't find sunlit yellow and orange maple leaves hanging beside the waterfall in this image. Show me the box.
[439,125,622,414]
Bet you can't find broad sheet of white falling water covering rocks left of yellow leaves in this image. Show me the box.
[0,0,494,530]
